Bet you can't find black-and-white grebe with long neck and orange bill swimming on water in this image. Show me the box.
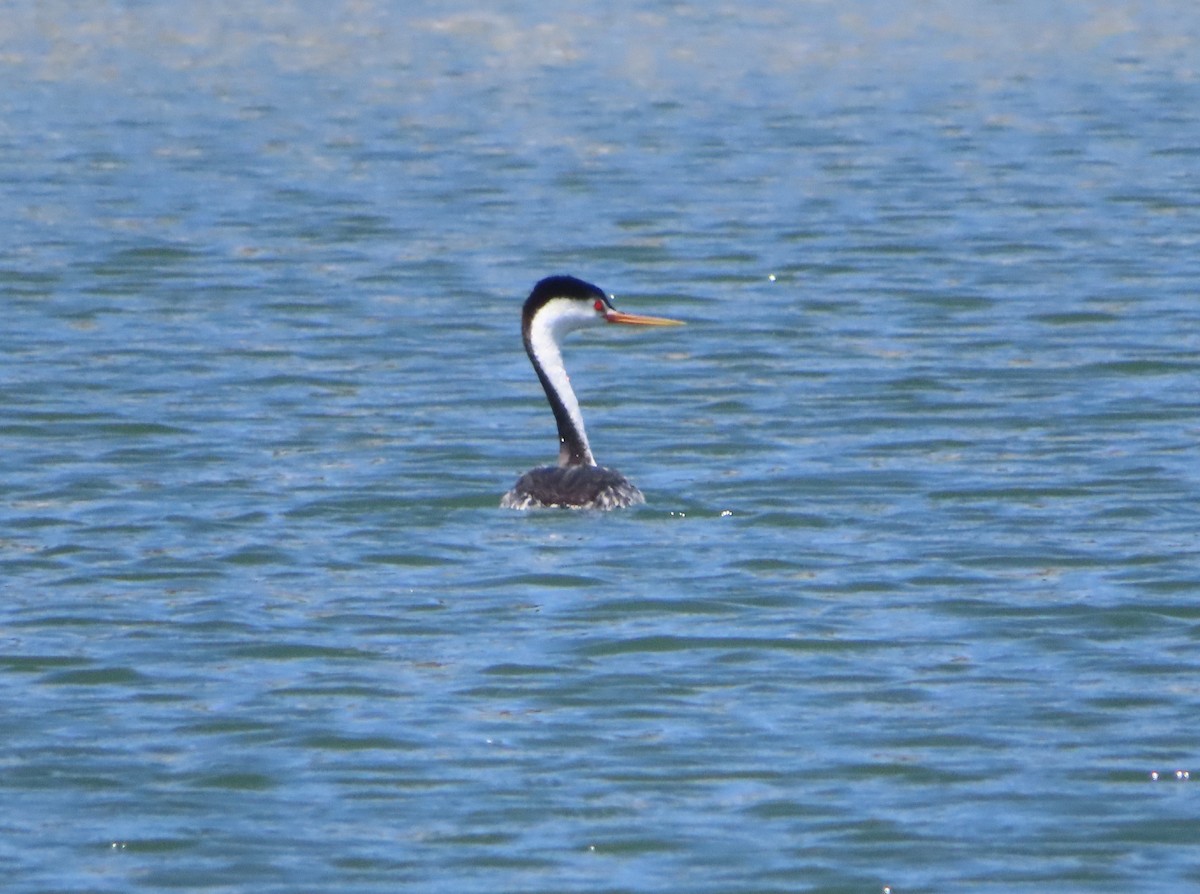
[500,276,679,509]
